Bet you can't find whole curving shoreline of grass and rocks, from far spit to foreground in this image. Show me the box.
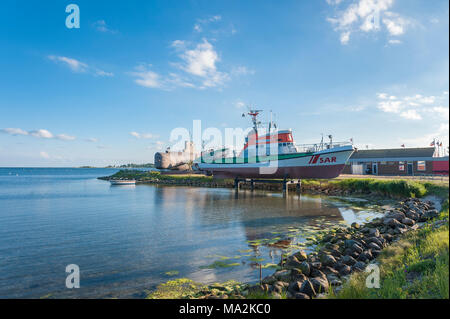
[106,171,448,299]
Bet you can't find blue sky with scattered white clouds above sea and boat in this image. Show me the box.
[0,0,449,166]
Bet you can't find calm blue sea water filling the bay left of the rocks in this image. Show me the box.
[0,168,384,298]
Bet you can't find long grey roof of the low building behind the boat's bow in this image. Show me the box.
[350,147,434,161]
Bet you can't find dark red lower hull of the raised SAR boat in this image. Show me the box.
[208,164,345,179]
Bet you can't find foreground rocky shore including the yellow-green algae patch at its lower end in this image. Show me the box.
[147,197,448,299]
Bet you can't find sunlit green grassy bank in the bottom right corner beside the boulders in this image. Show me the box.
[331,201,449,299]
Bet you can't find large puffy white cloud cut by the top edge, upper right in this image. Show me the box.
[327,0,411,45]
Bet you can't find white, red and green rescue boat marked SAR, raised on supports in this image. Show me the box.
[194,110,355,179]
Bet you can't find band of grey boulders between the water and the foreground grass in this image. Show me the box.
[243,198,438,299]
